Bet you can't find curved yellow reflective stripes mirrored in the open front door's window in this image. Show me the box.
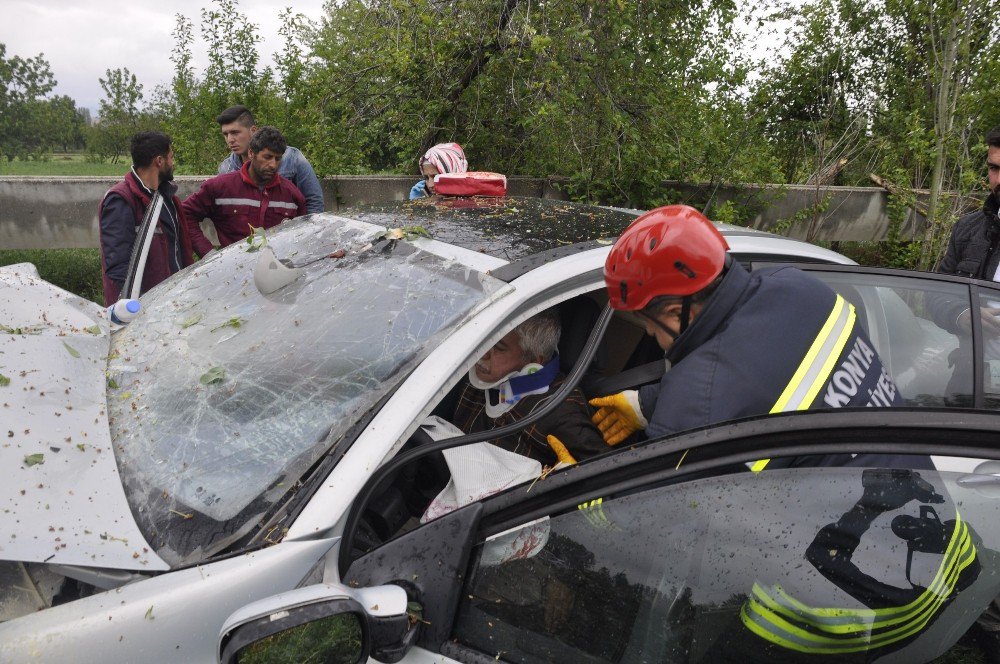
[740,515,976,654]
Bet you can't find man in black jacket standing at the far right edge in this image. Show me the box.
[930,127,1000,332]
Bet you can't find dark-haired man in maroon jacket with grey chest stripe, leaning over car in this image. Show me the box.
[183,127,306,256]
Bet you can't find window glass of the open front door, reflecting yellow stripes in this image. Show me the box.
[453,460,1000,662]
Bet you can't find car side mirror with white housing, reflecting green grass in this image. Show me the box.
[219,584,419,664]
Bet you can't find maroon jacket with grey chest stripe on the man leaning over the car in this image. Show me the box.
[183,162,306,256]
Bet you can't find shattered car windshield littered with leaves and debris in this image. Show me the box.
[108,215,502,565]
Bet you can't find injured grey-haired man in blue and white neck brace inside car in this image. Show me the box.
[452,311,608,466]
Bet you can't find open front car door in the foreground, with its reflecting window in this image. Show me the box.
[324,409,1000,662]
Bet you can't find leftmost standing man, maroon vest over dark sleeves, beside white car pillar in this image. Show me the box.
[98,131,192,306]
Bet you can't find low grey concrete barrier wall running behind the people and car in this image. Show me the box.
[0,175,952,249]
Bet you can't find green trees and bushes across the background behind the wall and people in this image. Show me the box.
[0,0,1000,268]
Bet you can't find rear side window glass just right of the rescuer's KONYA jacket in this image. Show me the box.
[810,271,974,407]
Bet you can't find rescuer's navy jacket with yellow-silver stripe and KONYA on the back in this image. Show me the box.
[639,263,902,438]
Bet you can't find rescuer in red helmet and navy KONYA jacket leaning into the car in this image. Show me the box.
[590,205,901,470]
